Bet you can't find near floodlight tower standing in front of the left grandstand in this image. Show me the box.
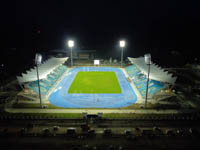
[35,53,42,108]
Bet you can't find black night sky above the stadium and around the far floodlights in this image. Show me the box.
[1,0,200,74]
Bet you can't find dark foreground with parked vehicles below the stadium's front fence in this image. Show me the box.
[0,119,200,150]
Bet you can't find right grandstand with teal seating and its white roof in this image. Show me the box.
[125,57,176,97]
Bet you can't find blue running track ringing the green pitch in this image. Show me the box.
[49,67,137,108]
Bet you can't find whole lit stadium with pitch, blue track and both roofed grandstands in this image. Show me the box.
[14,50,176,112]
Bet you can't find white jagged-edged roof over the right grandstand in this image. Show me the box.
[128,57,177,84]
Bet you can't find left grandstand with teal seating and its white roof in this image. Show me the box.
[17,57,68,97]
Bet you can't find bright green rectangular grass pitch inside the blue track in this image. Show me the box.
[68,71,121,94]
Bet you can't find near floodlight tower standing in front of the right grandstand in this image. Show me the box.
[144,54,151,109]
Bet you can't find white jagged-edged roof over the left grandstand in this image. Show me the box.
[17,57,68,84]
